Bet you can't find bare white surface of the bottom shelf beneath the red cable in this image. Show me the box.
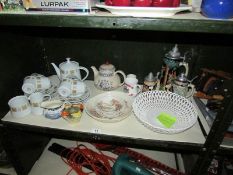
[29,139,184,175]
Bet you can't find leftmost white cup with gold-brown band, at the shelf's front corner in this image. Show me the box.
[8,95,31,117]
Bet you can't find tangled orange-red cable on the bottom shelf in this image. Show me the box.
[61,145,115,175]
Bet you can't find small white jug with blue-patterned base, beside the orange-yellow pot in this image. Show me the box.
[41,100,65,119]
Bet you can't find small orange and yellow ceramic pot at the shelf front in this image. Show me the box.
[61,103,84,123]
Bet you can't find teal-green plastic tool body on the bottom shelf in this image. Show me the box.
[112,154,153,175]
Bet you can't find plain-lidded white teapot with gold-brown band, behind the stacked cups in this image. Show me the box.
[51,58,89,81]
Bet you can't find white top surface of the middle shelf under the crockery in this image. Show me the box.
[2,81,205,144]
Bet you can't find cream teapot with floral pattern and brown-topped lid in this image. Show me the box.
[91,63,126,91]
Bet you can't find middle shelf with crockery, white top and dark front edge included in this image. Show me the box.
[2,81,205,152]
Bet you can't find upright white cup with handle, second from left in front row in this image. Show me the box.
[28,92,51,115]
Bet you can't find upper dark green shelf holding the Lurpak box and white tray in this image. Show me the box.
[0,11,233,34]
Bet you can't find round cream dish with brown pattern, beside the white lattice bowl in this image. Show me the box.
[86,91,133,122]
